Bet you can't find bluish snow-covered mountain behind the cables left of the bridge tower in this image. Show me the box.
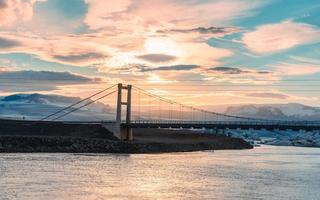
[0,94,113,121]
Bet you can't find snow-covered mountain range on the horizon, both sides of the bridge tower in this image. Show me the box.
[0,93,320,120]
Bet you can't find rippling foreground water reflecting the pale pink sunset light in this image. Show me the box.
[0,146,320,200]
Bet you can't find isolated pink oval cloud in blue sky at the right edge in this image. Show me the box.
[242,21,320,54]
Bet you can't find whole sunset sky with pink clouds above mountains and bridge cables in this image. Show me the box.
[0,0,320,106]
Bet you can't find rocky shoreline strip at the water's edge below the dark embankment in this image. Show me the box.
[0,136,252,153]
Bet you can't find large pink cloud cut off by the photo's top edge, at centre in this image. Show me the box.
[85,0,265,31]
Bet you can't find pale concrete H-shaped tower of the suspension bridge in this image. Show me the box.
[116,83,133,140]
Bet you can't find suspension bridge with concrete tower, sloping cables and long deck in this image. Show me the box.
[26,83,320,140]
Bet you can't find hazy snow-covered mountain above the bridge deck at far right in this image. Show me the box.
[225,103,320,120]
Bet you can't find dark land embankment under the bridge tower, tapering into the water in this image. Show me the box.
[0,120,252,153]
